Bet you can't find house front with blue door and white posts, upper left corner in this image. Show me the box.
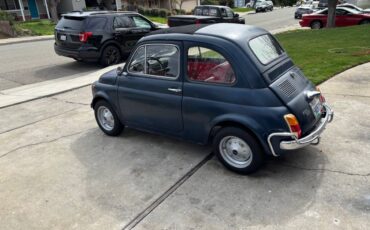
[0,0,50,21]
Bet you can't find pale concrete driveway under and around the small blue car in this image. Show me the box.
[0,63,370,229]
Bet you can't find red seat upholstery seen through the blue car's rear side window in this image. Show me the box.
[188,60,235,83]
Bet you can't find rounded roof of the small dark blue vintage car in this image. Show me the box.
[145,23,268,41]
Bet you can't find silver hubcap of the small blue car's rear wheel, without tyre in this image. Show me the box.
[219,136,253,168]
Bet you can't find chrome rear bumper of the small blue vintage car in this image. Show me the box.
[267,104,334,156]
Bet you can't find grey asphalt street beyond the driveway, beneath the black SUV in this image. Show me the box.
[0,8,298,90]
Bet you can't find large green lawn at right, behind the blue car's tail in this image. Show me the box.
[276,25,370,84]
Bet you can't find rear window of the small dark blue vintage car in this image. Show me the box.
[249,34,284,65]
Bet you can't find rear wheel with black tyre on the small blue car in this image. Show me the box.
[213,127,264,174]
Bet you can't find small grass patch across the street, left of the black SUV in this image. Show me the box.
[15,19,55,35]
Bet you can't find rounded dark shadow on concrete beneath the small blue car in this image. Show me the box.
[72,126,325,227]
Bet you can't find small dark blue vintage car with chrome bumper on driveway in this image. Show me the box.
[91,24,334,174]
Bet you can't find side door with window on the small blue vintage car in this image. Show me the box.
[118,43,183,135]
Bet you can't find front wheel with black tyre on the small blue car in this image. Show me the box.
[94,100,124,136]
